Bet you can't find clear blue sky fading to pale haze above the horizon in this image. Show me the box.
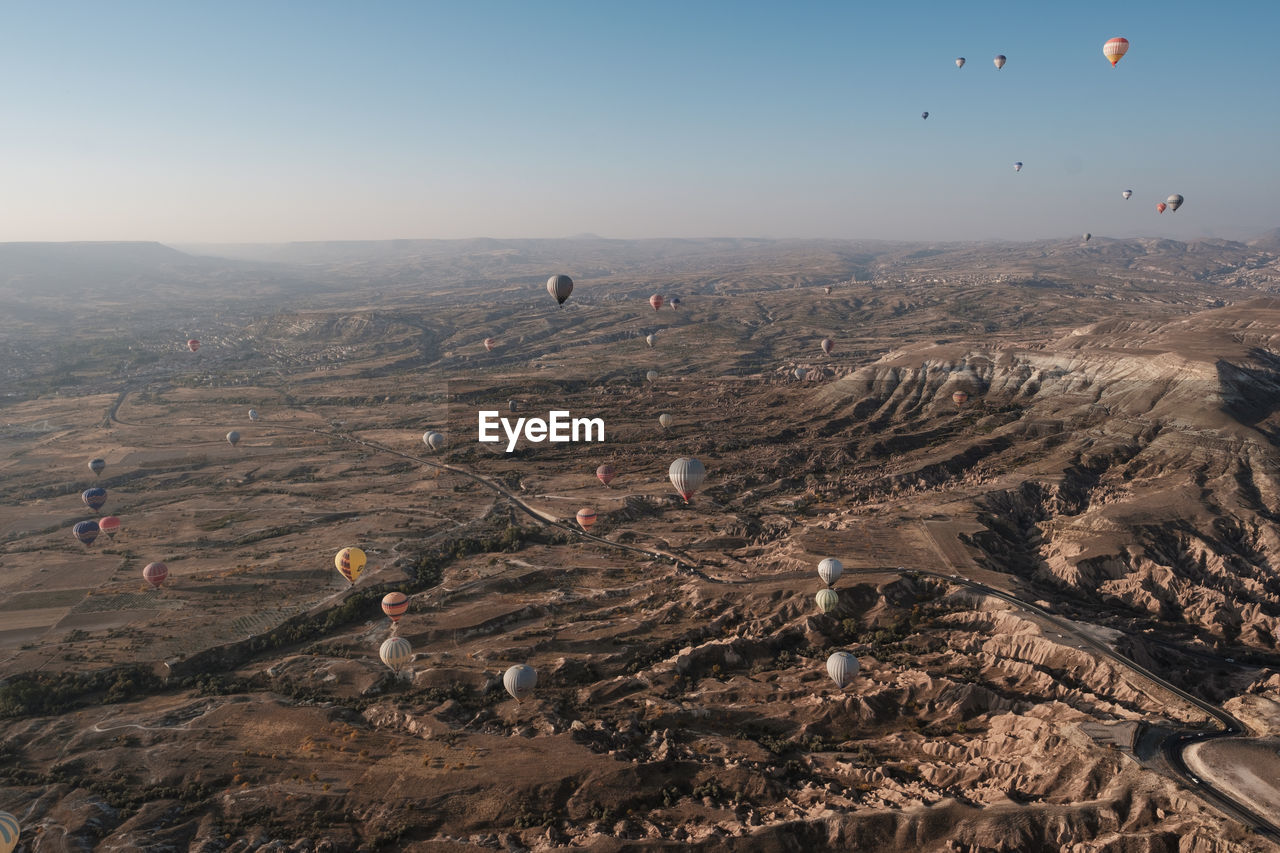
[0,0,1280,242]
